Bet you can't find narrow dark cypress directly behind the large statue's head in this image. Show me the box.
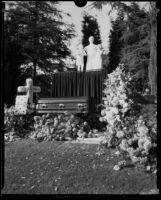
[82,14,101,47]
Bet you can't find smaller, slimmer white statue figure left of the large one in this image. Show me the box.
[76,44,85,71]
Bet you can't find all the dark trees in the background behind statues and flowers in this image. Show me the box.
[3,1,158,106]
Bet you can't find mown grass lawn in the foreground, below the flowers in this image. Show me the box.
[2,139,157,194]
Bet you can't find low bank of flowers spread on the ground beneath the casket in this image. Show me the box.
[30,112,98,141]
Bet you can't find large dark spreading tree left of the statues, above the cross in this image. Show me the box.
[4,1,74,106]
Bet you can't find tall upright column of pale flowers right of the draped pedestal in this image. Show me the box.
[100,65,133,147]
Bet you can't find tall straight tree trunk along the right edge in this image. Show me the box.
[149,2,157,96]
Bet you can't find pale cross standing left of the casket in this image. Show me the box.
[17,78,41,106]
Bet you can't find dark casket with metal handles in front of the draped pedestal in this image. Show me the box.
[36,97,94,113]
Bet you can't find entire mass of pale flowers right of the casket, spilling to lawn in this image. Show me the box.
[100,65,157,170]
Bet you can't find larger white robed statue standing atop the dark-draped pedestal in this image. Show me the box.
[84,36,102,71]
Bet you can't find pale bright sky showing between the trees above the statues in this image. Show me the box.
[58,1,147,55]
